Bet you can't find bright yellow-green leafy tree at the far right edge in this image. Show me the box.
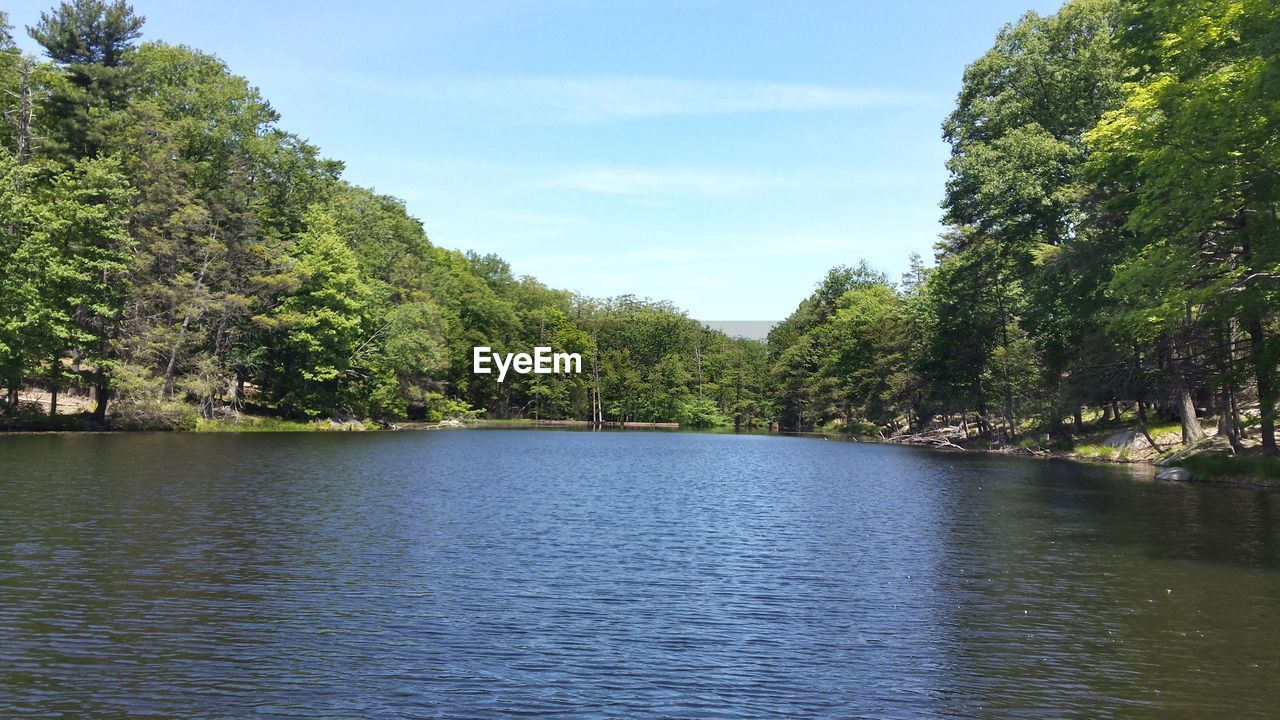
[1089,0,1280,455]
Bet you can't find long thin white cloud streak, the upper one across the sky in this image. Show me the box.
[362,76,928,124]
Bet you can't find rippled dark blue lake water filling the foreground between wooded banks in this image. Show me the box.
[0,430,1280,717]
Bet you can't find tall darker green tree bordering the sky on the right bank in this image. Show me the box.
[931,0,1121,433]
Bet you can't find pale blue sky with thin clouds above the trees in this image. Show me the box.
[5,0,1059,320]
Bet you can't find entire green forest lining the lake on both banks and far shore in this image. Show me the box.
[0,0,1280,455]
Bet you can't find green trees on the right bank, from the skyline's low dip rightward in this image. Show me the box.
[768,0,1280,455]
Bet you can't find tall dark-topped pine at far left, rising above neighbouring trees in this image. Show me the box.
[19,0,143,420]
